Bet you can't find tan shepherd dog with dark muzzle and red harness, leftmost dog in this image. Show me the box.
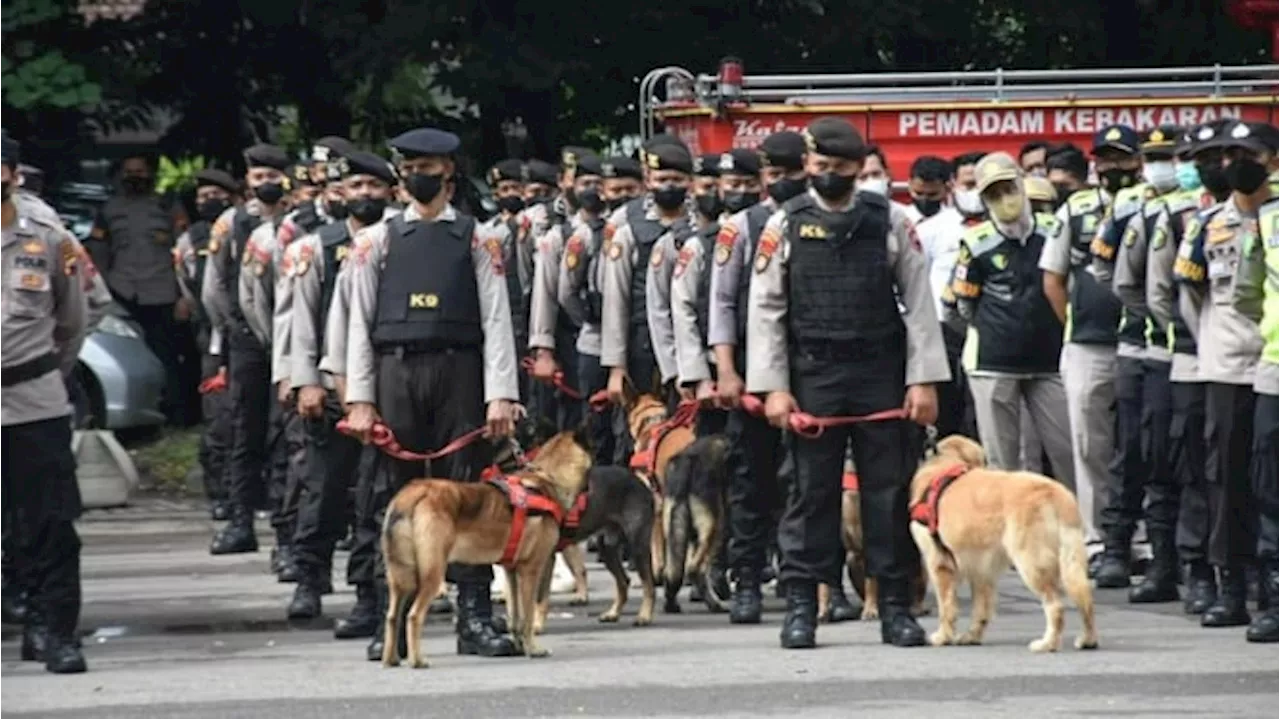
[381,430,591,668]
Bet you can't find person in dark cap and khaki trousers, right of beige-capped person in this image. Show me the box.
[1039,125,1142,569]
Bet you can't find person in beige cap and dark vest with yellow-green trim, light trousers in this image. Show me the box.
[947,152,1074,478]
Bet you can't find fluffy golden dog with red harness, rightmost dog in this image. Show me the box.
[911,435,1098,651]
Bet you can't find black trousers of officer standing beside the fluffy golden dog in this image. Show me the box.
[778,351,920,588]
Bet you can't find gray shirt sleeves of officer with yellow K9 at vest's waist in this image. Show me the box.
[346,205,520,404]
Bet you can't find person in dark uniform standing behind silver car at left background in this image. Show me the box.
[87,151,187,425]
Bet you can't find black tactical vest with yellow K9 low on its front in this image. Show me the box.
[372,212,484,352]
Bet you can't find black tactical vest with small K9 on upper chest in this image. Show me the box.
[778,193,906,356]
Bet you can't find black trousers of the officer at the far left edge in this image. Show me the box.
[0,417,83,638]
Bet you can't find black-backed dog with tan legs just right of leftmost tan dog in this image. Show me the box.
[534,467,655,633]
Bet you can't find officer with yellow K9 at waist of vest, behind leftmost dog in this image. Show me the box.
[346,128,518,660]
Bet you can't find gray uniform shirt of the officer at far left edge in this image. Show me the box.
[0,205,88,427]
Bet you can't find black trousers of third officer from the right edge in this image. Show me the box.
[1169,383,1210,564]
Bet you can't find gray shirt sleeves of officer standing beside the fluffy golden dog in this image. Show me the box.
[746,191,951,394]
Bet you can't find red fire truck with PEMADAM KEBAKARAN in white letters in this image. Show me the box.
[640,58,1280,180]
